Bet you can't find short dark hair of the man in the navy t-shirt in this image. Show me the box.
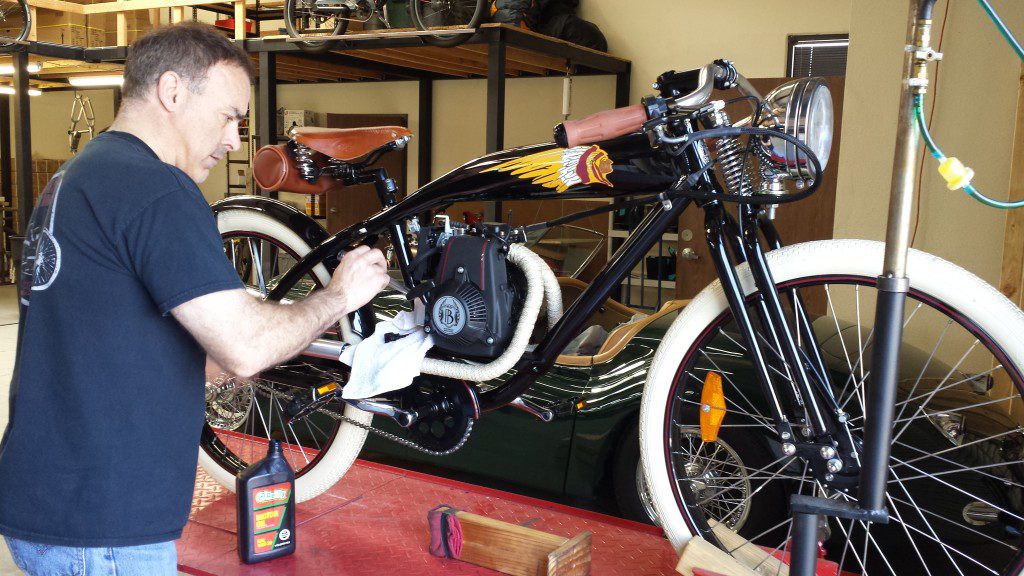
[121,23,256,99]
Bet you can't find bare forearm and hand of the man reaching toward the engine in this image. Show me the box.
[171,246,388,378]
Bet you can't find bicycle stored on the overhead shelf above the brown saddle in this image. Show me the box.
[285,0,487,53]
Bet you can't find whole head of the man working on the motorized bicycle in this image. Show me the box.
[122,24,254,182]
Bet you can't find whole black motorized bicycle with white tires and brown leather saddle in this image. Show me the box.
[201,0,1024,575]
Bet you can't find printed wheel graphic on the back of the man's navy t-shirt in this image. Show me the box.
[20,172,63,305]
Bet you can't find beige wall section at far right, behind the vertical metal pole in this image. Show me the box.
[835,0,1024,284]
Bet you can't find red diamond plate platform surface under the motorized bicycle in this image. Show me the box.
[178,455,677,576]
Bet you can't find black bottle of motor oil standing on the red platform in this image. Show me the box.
[234,440,295,564]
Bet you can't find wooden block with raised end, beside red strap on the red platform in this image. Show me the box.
[434,511,591,576]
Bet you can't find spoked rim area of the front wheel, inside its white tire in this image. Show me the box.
[666,277,1024,575]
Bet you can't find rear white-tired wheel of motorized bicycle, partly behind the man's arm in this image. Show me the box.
[200,209,373,502]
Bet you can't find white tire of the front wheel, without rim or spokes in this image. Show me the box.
[640,240,1024,550]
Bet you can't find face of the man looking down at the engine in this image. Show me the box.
[174,63,249,183]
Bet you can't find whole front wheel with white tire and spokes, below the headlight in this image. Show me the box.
[640,235,1024,576]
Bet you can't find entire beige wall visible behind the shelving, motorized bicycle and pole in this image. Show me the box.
[24,0,1024,291]
